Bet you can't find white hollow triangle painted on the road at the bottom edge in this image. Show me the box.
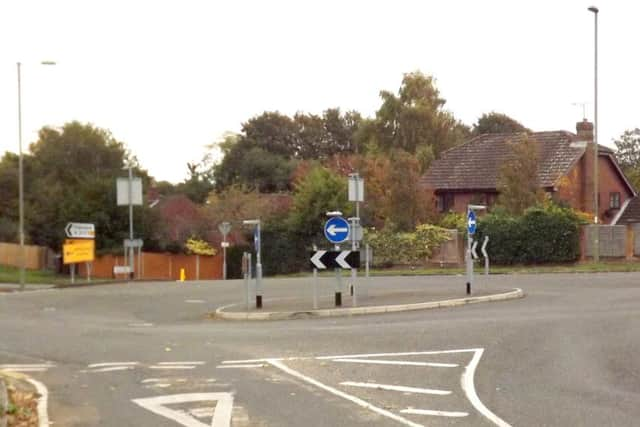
[132,393,233,427]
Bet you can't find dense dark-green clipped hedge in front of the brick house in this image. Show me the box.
[476,205,582,265]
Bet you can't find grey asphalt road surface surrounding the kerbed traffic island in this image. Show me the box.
[0,273,640,427]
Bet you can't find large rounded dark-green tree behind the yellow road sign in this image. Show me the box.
[17,122,160,249]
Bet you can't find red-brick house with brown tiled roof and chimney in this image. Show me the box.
[421,120,636,224]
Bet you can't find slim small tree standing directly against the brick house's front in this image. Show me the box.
[497,138,544,215]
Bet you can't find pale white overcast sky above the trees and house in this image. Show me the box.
[0,0,640,182]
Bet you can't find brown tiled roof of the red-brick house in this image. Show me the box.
[421,131,596,190]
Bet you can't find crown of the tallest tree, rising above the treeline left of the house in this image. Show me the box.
[367,71,465,156]
